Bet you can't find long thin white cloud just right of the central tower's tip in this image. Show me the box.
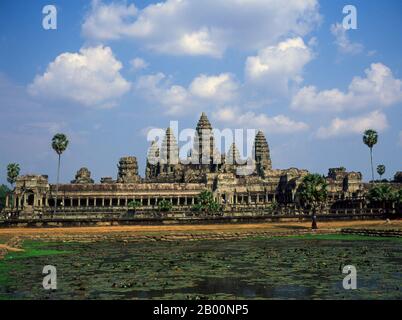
[213,107,308,133]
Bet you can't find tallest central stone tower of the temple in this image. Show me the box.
[192,112,220,165]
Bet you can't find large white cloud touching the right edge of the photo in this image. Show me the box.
[291,63,402,112]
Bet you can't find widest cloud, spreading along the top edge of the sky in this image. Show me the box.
[82,0,320,57]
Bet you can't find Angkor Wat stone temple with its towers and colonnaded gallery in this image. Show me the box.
[3,113,370,217]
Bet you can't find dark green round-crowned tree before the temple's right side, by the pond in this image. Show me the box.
[296,174,328,215]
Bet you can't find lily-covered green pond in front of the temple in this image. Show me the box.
[0,235,402,299]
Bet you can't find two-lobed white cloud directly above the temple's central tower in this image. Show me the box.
[135,73,239,115]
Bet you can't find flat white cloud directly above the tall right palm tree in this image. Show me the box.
[316,110,388,139]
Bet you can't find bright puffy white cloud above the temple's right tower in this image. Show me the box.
[245,37,313,89]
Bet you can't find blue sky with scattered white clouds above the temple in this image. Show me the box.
[0,0,402,183]
